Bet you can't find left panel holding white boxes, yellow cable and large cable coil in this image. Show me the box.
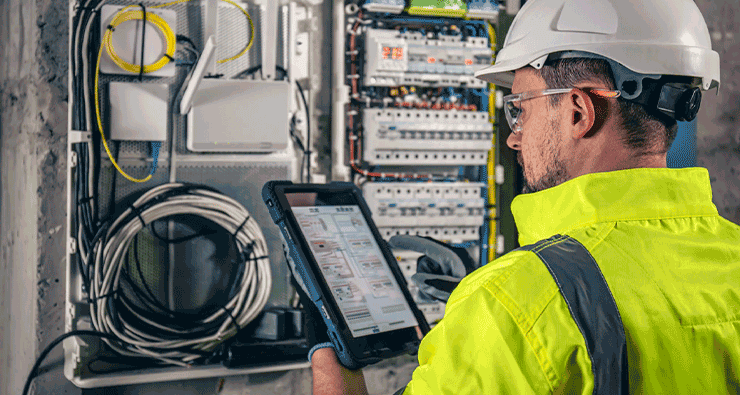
[65,0,316,388]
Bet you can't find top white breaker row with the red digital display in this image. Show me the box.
[364,29,493,89]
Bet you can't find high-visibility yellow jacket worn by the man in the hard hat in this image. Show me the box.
[404,168,740,394]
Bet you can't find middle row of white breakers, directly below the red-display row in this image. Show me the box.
[363,109,493,166]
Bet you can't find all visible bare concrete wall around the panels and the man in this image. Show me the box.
[0,0,740,395]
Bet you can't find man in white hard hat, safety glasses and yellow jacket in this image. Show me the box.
[313,0,740,394]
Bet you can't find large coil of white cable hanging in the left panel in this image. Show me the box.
[89,183,272,366]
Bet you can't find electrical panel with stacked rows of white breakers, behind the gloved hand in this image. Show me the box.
[342,0,499,332]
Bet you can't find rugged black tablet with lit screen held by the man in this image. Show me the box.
[262,181,429,369]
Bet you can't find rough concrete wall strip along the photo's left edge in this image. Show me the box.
[0,0,71,394]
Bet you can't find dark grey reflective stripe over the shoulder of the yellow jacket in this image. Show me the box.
[515,235,629,395]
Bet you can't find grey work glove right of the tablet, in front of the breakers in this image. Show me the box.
[388,235,475,302]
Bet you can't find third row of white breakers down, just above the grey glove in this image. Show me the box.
[363,182,485,242]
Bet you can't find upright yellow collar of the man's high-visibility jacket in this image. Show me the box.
[511,167,718,246]
